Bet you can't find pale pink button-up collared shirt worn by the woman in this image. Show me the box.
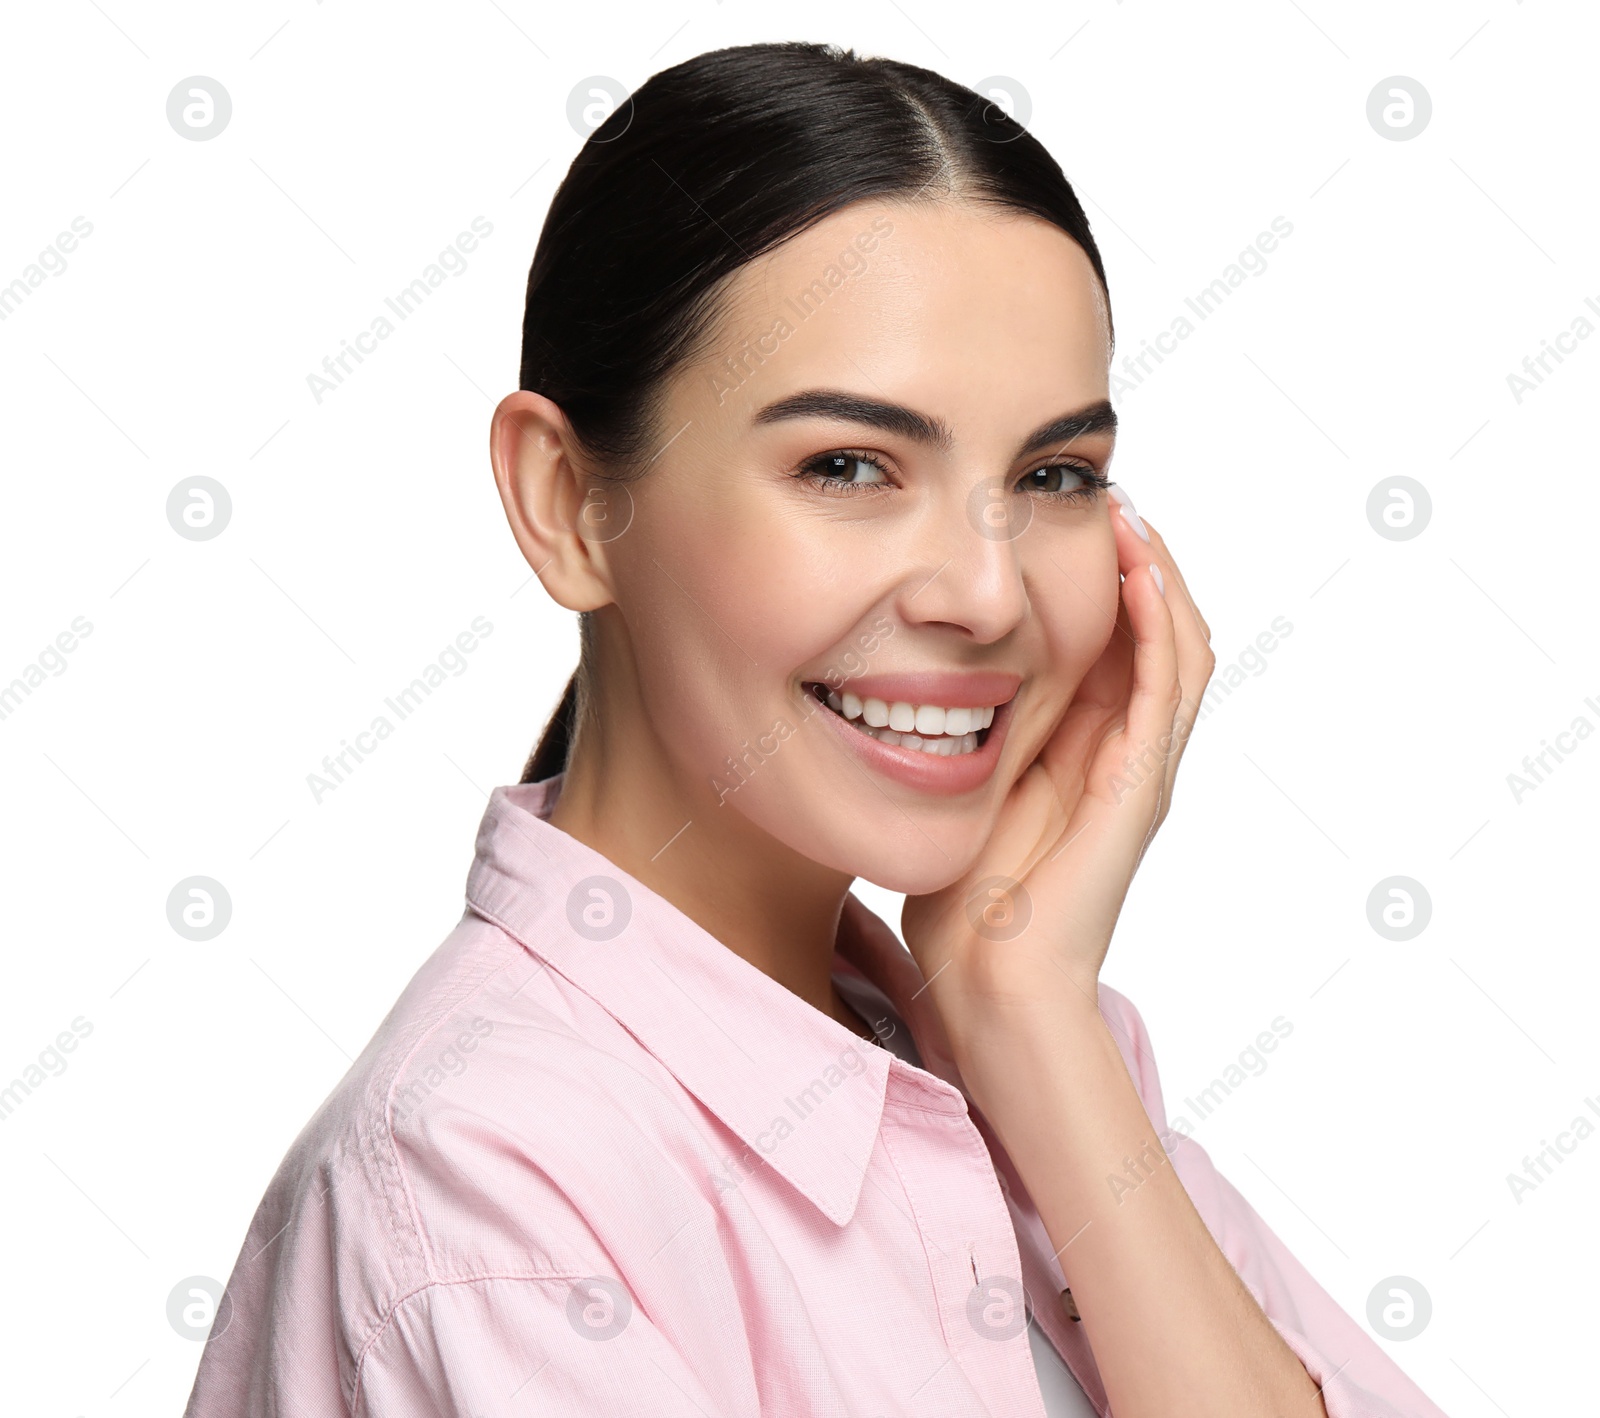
[186,778,1443,1418]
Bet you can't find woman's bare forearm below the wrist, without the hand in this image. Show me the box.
[957,1000,1325,1418]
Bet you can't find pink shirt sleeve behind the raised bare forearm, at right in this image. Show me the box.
[1101,986,1445,1418]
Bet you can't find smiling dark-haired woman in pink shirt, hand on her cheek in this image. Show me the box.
[187,45,1438,1418]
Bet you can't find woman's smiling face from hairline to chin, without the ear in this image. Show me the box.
[594,200,1118,895]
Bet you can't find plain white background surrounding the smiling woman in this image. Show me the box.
[0,0,1600,1418]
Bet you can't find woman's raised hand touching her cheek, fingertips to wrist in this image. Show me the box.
[901,489,1216,1056]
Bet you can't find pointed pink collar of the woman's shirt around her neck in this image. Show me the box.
[467,775,966,1226]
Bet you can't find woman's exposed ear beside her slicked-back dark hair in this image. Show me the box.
[490,389,613,611]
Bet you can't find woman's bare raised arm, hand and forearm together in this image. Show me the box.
[901,489,1328,1418]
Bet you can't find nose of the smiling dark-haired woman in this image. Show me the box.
[894,479,1030,645]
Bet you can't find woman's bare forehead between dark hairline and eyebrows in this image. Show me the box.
[685,198,1110,431]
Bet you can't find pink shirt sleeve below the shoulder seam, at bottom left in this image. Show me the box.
[354,1276,731,1418]
